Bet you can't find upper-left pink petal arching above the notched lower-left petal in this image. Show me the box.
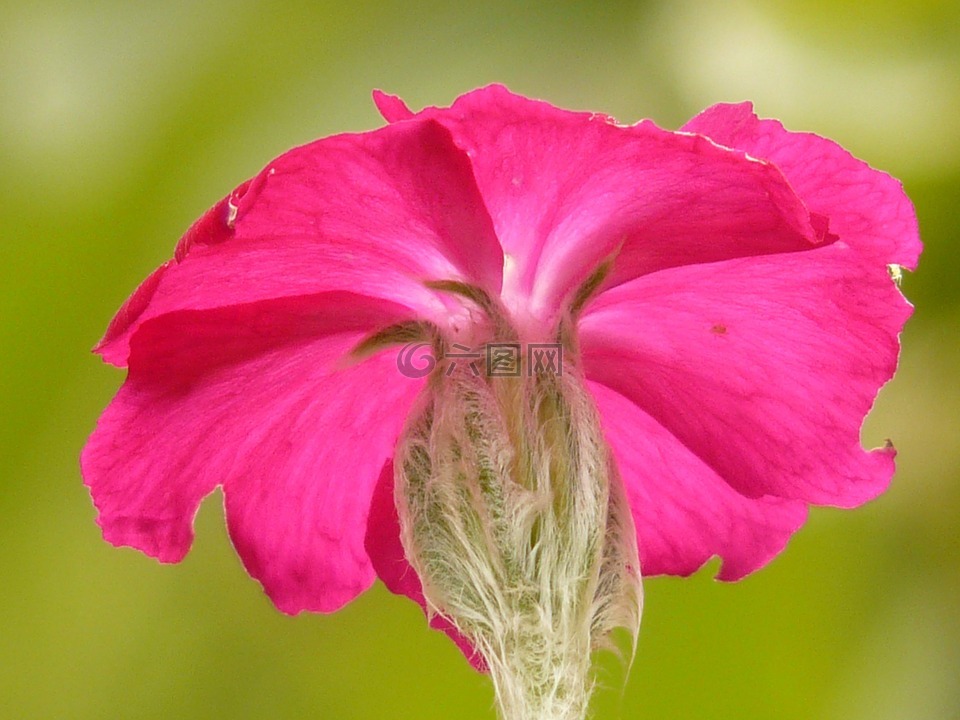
[97,120,503,365]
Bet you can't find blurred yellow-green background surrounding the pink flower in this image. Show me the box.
[0,0,960,720]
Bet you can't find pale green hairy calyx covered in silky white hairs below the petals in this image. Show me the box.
[394,336,642,720]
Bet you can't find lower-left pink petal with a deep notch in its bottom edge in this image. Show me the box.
[82,293,421,613]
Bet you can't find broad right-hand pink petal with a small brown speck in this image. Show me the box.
[580,244,910,507]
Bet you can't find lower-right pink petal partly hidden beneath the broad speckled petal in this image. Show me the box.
[588,382,807,580]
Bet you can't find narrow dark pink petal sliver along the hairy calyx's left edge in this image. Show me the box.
[366,462,487,672]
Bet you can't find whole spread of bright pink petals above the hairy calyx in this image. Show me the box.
[82,87,920,672]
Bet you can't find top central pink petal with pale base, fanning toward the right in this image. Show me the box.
[380,86,824,324]
